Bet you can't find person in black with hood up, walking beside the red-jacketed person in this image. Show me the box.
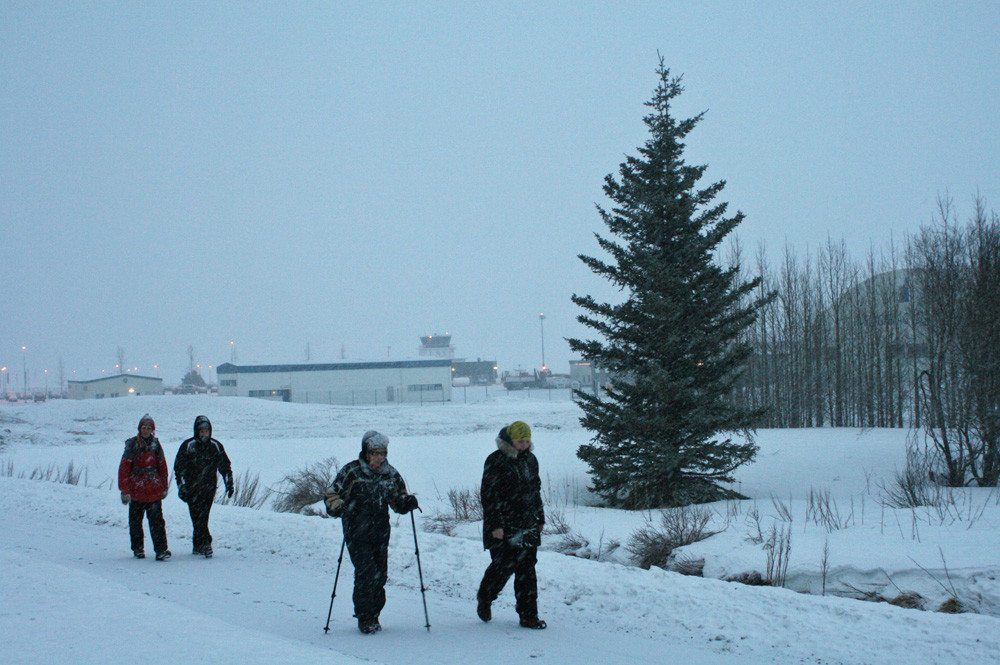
[174,416,234,559]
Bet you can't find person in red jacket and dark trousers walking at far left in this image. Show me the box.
[118,413,170,561]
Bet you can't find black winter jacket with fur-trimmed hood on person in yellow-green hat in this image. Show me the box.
[480,427,545,549]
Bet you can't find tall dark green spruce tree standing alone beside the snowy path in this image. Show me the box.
[568,58,770,508]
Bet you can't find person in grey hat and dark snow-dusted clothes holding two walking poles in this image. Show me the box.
[325,430,419,634]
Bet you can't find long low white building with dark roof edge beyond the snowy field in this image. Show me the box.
[221,358,451,404]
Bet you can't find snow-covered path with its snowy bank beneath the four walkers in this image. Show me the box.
[0,478,1000,665]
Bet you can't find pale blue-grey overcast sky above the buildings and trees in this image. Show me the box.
[0,0,1000,389]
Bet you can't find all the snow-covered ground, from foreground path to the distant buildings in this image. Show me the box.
[0,391,1000,665]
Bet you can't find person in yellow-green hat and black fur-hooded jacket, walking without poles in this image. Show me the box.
[476,420,545,629]
